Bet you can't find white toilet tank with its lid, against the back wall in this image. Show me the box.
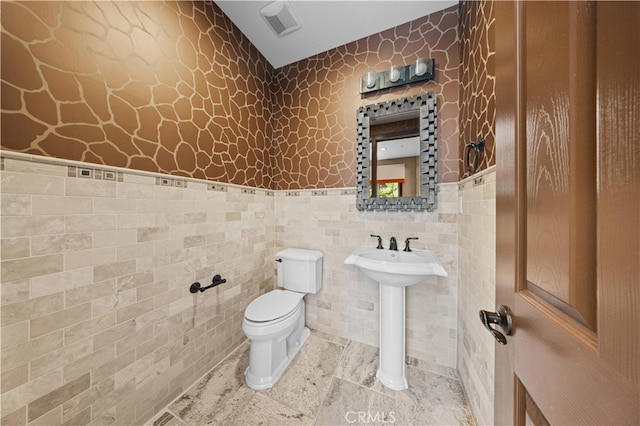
[276,248,323,294]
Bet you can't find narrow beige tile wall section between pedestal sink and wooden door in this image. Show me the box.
[458,167,496,425]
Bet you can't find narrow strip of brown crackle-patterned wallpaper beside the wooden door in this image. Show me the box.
[459,0,496,179]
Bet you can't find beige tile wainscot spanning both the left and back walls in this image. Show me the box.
[0,153,458,425]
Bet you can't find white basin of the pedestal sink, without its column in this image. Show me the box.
[344,246,448,287]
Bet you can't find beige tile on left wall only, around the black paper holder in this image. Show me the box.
[0,153,275,425]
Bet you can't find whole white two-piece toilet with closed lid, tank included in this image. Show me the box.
[242,248,323,390]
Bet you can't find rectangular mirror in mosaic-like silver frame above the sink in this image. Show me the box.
[356,92,438,211]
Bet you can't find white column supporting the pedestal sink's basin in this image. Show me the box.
[376,283,409,390]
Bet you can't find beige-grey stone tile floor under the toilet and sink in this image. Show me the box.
[149,332,474,426]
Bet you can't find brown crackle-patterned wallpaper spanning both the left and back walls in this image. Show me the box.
[0,1,459,189]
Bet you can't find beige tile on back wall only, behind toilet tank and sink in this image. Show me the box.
[275,184,458,369]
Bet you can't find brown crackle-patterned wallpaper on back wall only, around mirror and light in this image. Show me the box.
[273,7,459,189]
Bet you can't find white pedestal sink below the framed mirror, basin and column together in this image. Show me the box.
[344,246,448,390]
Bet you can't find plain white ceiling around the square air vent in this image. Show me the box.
[214,0,458,68]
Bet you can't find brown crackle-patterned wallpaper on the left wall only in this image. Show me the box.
[1,1,273,188]
